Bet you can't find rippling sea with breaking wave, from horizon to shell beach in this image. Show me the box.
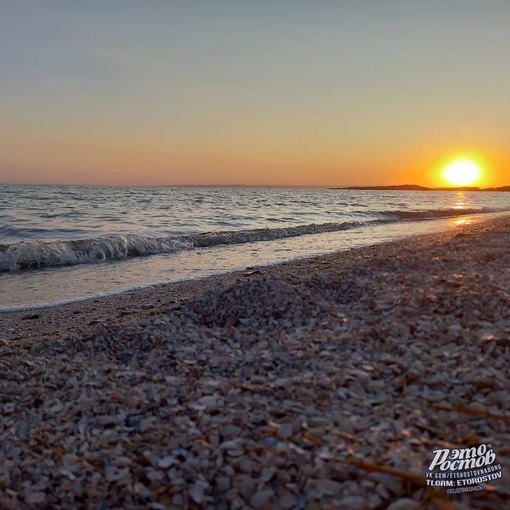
[0,185,510,312]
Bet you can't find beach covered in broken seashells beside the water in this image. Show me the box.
[0,217,510,510]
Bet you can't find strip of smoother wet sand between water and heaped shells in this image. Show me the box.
[0,216,510,341]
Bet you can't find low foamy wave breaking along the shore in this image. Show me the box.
[0,209,504,272]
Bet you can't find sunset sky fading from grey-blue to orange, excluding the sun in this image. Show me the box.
[0,0,510,186]
